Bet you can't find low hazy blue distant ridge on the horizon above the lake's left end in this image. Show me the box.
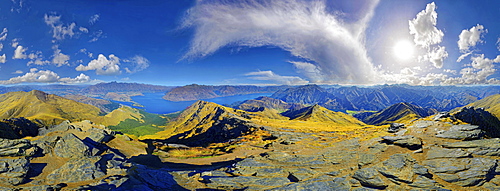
[82,82,173,94]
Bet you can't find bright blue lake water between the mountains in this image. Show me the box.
[114,93,271,114]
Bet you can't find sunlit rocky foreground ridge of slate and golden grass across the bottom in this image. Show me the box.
[0,109,500,190]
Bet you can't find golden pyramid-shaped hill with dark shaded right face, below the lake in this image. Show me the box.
[149,101,258,146]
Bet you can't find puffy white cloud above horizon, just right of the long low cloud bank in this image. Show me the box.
[76,54,121,75]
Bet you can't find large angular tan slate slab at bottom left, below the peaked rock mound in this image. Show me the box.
[47,156,106,184]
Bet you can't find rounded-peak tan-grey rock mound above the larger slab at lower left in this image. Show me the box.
[54,133,92,158]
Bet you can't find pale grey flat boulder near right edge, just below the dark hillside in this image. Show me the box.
[436,124,484,140]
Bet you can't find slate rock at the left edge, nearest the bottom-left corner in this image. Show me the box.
[0,158,30,186]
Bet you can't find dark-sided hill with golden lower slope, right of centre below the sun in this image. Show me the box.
[354,103,436,125]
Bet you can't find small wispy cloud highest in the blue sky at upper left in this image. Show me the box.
[44,14,76,40]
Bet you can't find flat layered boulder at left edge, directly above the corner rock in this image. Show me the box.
[0,139,37,156]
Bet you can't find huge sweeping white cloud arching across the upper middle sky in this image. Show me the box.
[181,0,378,83]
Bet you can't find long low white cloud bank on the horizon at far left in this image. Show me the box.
[0,68,90,85]
